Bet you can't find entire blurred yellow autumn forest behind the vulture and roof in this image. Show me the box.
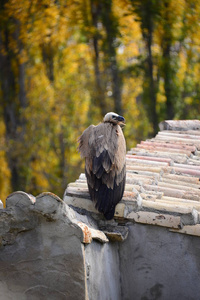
[0,0,200,205]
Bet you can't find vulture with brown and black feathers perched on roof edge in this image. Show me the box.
[78,112,126,220]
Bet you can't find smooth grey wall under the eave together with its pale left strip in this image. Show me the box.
[85,224,200,300]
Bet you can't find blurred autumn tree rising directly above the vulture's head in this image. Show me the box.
[81,0,122,116]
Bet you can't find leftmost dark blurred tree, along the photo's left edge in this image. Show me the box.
[0,0,28,190]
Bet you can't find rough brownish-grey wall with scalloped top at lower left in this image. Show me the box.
[0,195,86,300]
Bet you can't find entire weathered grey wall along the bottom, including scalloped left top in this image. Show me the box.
[0,193,200,300]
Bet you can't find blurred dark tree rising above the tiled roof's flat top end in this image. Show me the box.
[157,1,187,119]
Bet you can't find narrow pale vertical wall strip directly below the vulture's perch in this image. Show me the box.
[85,241,122,300]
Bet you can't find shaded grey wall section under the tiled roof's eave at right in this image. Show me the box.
[119,224,200,300]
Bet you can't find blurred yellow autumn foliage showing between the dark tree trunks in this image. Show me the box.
[0,0,200,199]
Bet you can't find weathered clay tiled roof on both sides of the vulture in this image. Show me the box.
[64,120,200,236]
